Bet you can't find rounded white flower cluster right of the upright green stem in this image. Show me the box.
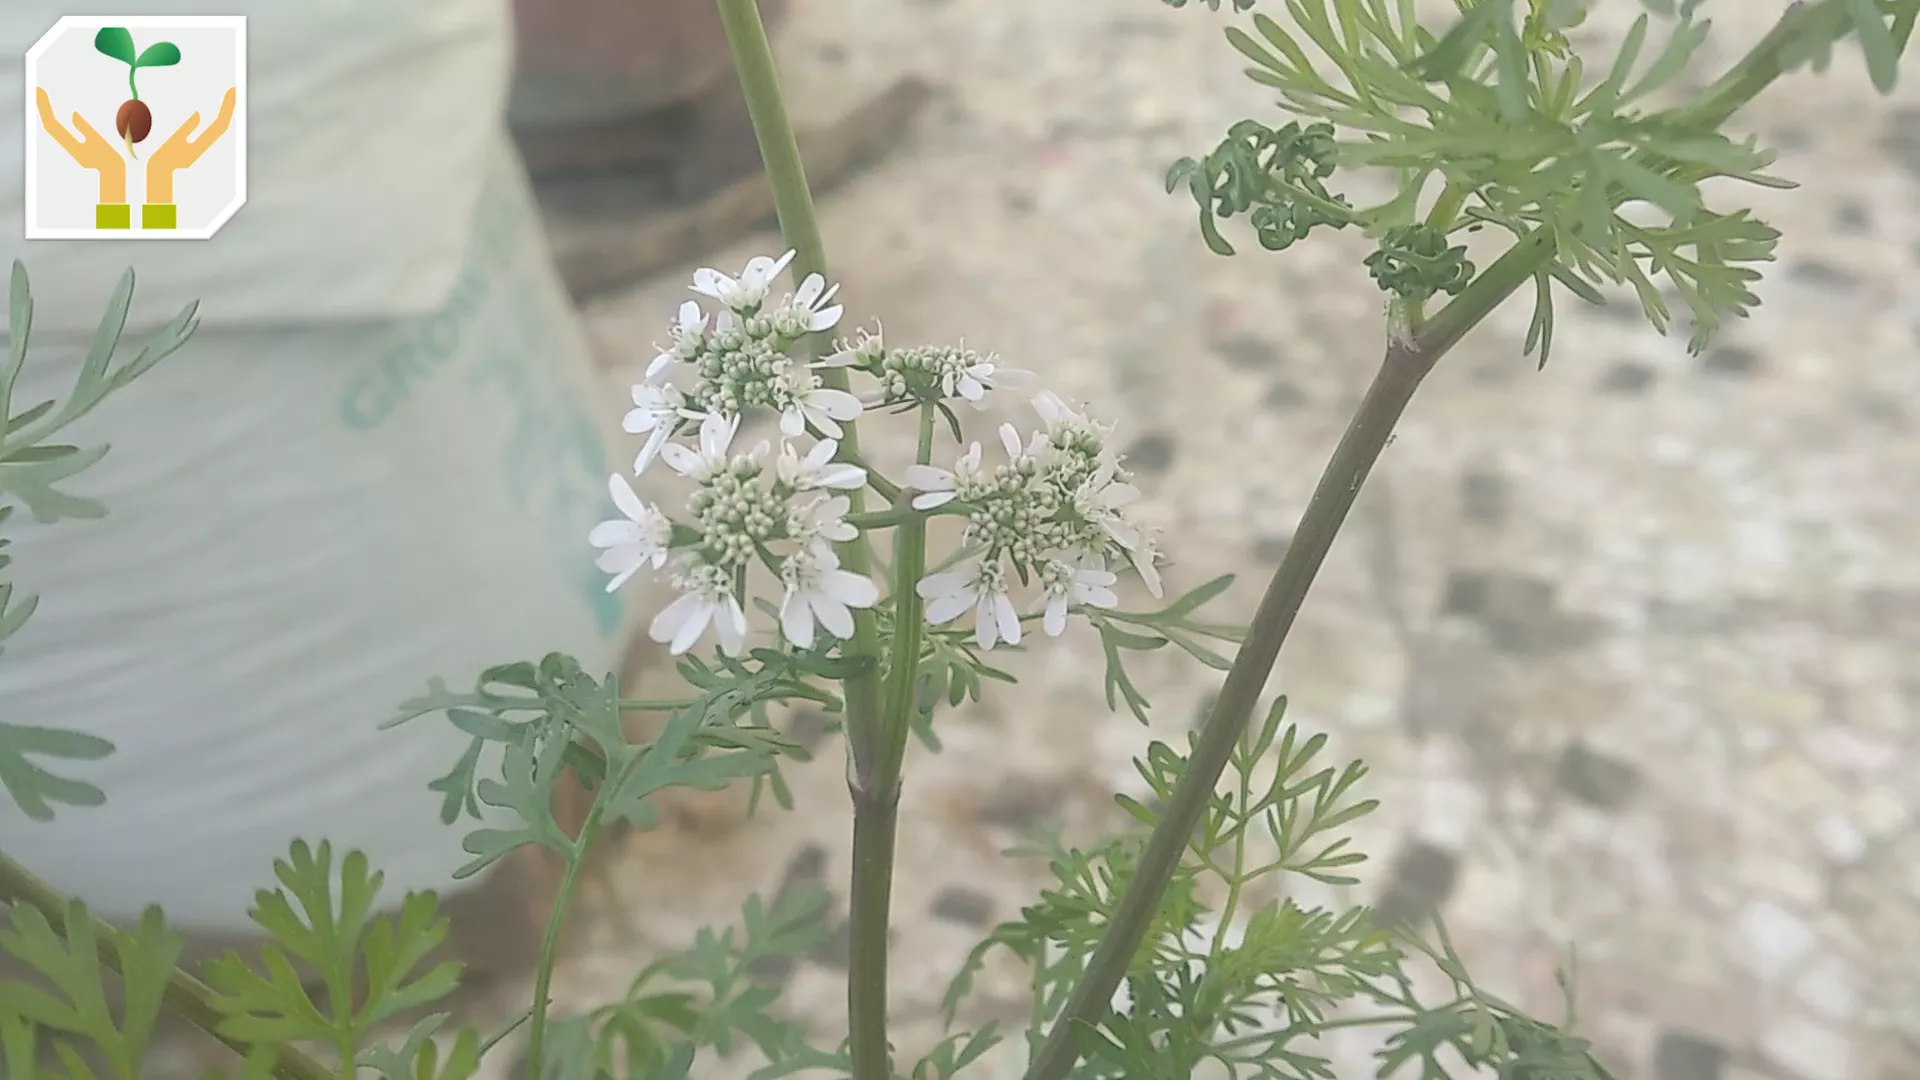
[906,394,1162,650]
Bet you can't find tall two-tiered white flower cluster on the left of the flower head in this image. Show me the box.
[588,252,879,655]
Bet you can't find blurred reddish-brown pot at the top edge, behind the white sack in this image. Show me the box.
[507,0,789,129]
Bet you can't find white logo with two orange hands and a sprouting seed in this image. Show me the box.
[27,17,246,238]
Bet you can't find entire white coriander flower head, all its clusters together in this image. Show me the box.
[589,252,1160,655]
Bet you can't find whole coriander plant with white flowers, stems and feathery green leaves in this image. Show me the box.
[0,0,1920,1080]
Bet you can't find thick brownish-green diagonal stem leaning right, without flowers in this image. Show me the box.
[1025,0,1843,1080]
